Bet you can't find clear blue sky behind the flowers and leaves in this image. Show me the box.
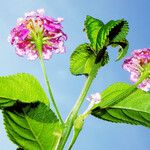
[0,0,150,150]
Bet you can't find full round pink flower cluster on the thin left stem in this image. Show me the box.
[8,9,67,60]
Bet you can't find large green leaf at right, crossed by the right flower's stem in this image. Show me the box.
[92,83,150,127]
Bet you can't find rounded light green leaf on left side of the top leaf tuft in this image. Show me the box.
[70,44,96,75]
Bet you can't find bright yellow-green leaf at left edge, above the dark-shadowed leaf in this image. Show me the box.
[0,73,49,108]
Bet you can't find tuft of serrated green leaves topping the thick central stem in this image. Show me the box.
[70,16,128,76]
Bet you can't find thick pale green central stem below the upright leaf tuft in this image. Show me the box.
[57,72,95,150]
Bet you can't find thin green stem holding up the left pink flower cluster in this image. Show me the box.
[36,38,64,124]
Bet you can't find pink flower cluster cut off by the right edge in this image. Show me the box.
[123,48,150,91]
